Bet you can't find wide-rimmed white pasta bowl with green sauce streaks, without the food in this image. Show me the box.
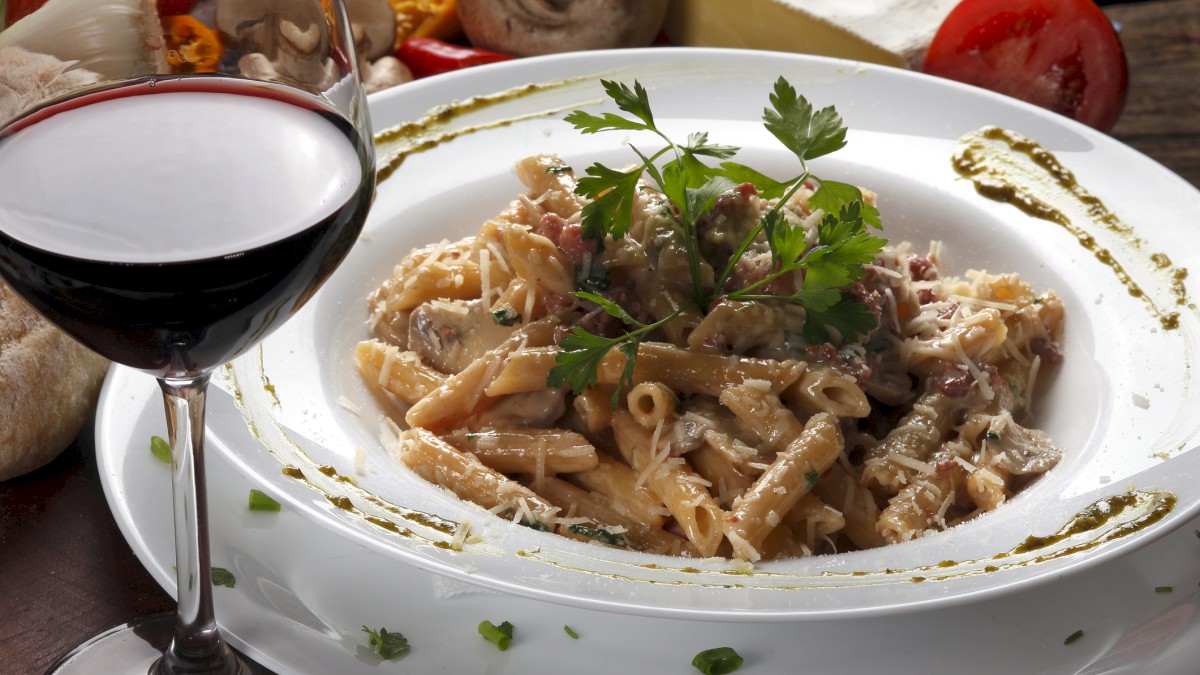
[112,49,1200,621]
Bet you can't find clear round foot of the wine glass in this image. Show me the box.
[46,614,274,675]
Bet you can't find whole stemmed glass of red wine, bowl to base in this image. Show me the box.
[0,0,374,674]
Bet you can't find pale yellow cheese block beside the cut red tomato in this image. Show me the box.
[664,0,959,70]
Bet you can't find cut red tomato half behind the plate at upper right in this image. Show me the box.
[923,0,1129,131]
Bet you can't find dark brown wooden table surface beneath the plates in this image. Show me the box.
[0,0,1200,674]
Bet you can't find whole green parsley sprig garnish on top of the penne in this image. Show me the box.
[547,77,887,398]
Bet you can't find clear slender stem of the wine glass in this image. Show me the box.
[155,374,239,675]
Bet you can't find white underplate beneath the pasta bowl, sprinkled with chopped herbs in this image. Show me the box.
[96,369,1200,675]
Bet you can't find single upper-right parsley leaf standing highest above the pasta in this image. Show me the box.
[762,77,846,161]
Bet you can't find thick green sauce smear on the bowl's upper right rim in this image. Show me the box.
[952,126,1195,330]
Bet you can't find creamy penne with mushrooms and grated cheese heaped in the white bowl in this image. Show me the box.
[355,79,1063,562]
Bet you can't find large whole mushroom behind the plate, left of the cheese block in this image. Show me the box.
[458,0,667,56]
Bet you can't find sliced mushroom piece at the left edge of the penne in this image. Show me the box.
[408,300,515,374]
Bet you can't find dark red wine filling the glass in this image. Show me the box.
[0,77,374,376]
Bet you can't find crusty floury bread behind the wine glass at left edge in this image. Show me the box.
[0,281,108,480]
